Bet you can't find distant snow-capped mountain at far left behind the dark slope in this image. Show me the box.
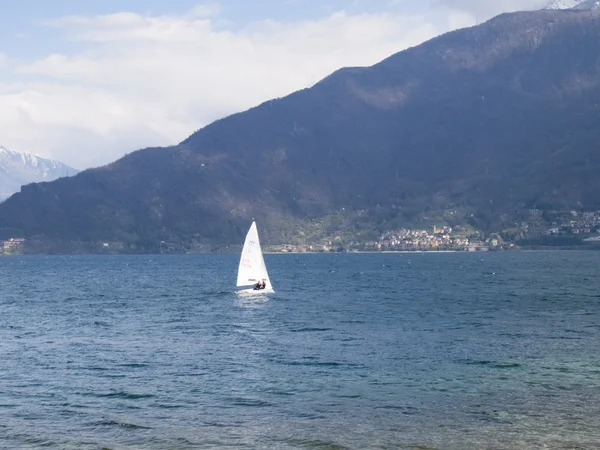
[0,146,78,201]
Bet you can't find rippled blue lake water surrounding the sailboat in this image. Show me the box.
[0,252,600,450]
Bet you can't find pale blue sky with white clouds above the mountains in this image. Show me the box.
[0,0,548,169]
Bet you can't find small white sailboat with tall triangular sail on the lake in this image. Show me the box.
[237,219,275,294]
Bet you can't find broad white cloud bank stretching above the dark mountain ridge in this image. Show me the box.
[0,5,472,168]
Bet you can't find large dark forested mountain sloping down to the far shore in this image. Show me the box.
[0,10,600,251]
